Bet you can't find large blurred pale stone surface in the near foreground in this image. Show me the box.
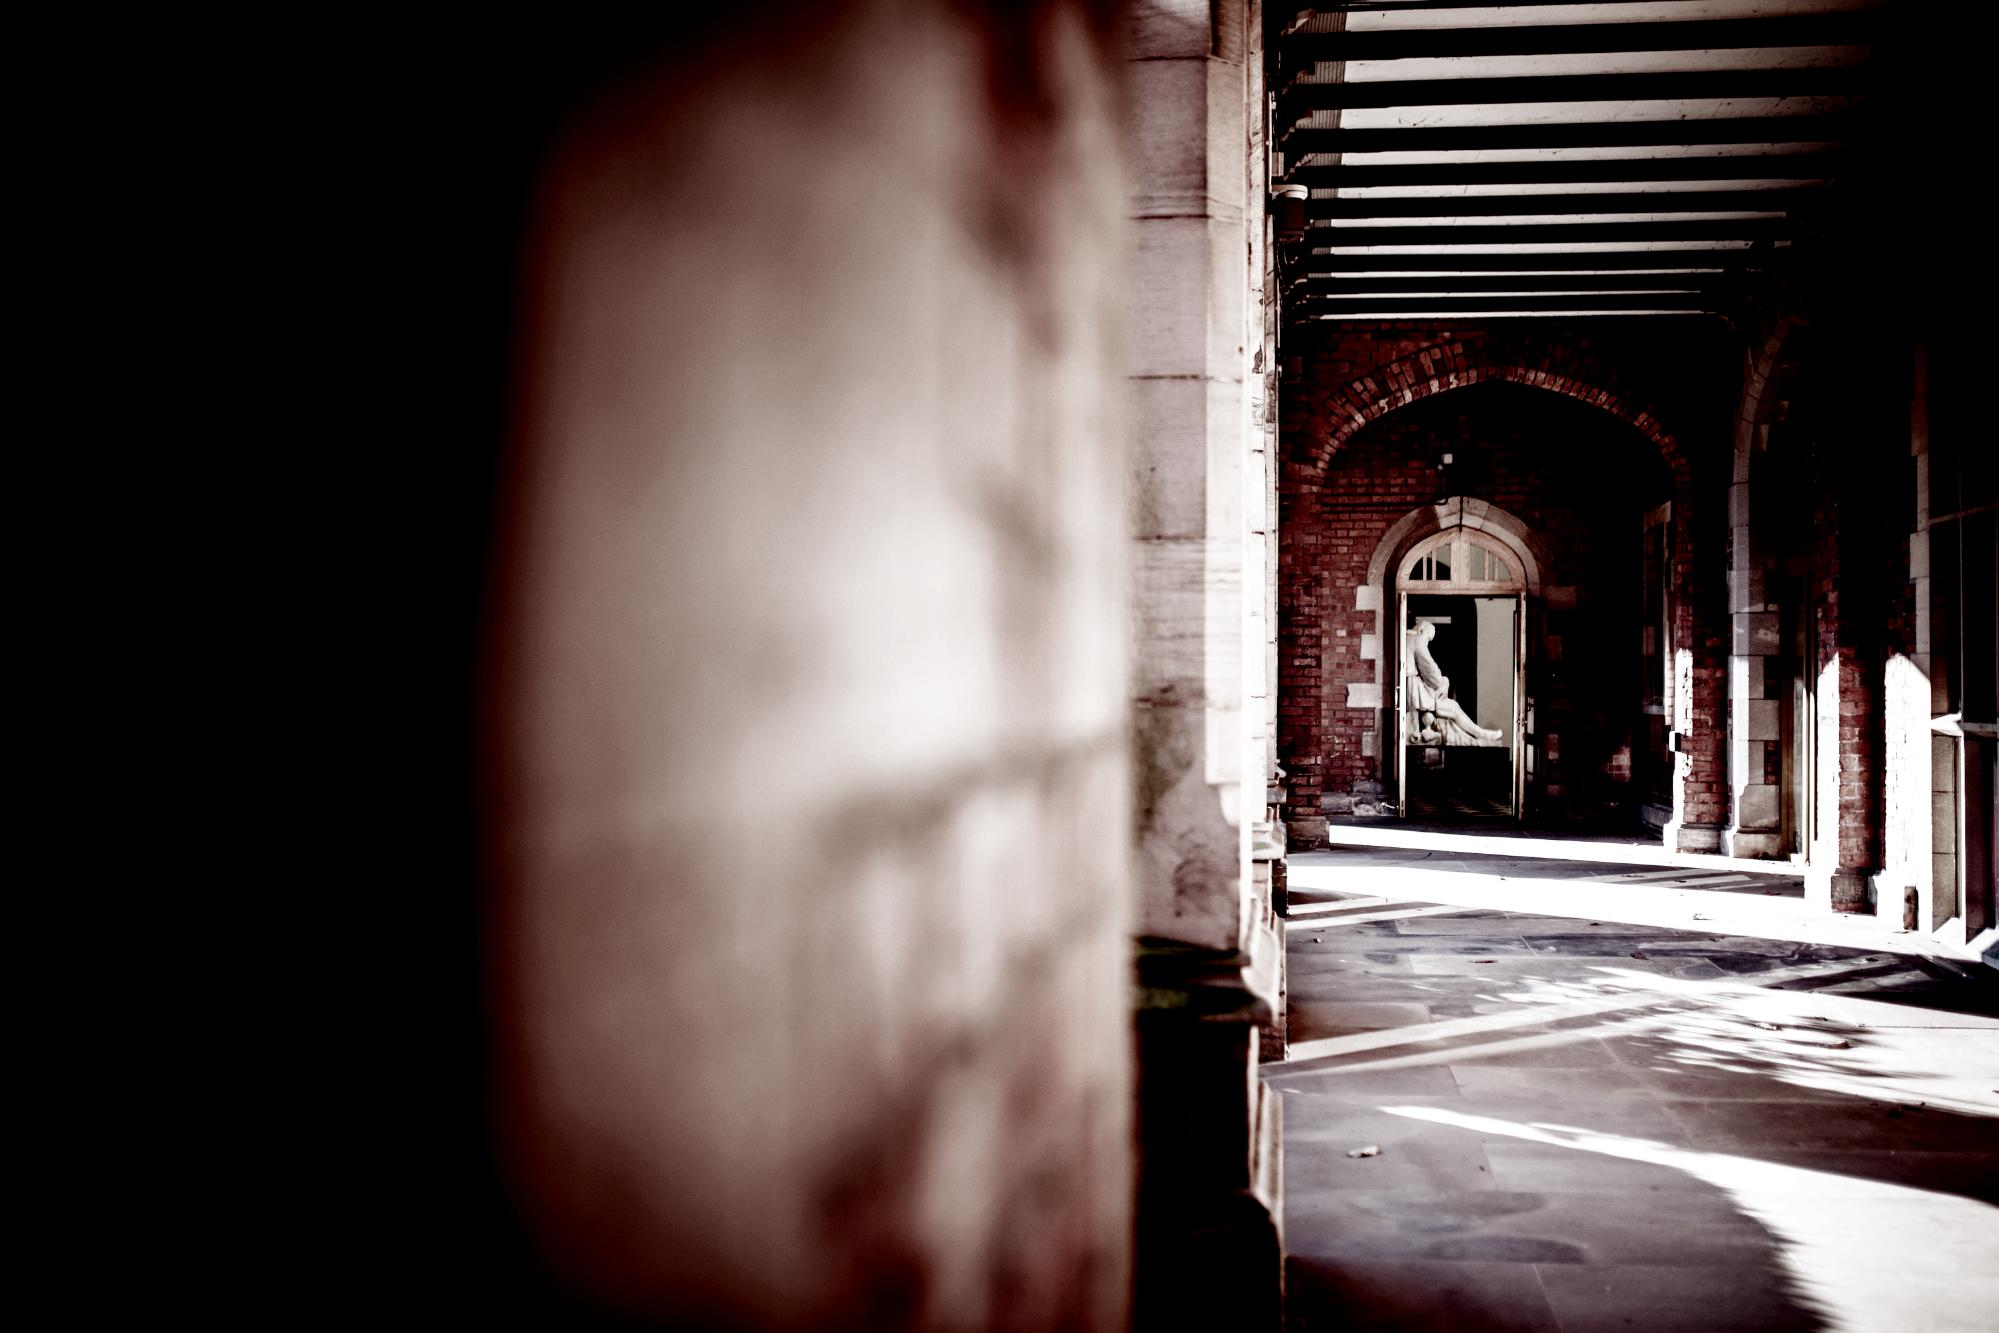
[488,2,1133,1329]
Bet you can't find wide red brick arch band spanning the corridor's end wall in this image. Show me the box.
[1299,334,1691,486]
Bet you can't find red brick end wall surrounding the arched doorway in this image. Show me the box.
[1277,324,1739,839]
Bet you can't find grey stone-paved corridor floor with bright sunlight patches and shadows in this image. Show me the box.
[1265,847,1999,1333]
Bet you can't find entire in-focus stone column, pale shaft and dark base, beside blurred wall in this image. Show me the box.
[1127,0,1283,1329]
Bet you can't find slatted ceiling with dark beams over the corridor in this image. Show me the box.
[1271,0,1885,322]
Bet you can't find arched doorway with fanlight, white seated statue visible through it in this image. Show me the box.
[1393,526,1531,819]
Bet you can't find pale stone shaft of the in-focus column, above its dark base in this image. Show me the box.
[1127,2,1263,949]
